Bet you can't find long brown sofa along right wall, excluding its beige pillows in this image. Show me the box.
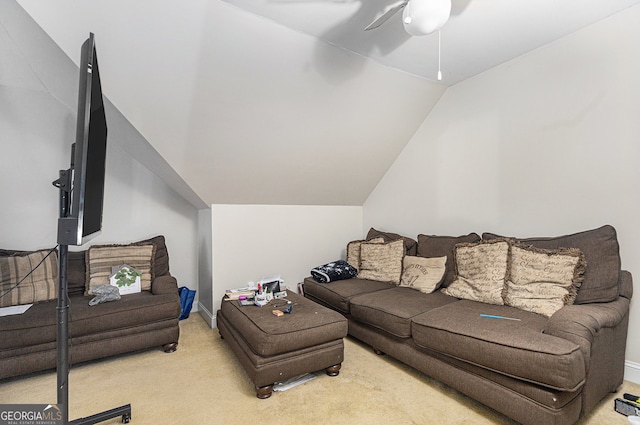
[304,226,633,425]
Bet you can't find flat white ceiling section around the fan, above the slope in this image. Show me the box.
[224,0,640,86]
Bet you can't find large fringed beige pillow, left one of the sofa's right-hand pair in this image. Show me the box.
[442,239,509,305]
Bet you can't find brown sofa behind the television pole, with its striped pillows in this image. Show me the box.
[0,236,180,379]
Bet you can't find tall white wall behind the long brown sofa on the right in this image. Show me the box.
[364,7,640,382]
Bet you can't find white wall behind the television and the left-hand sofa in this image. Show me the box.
[0,2,198,288]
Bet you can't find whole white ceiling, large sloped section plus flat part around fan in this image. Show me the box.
[18,0,640,205]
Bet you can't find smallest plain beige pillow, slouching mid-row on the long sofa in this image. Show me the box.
[400,255,447,294]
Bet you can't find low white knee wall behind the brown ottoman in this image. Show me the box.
[201,205,362,327]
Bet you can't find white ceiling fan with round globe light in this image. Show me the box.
[365,0,451,35]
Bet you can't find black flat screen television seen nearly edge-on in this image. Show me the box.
[58,33,107,245]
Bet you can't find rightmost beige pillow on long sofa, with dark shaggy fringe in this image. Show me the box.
[504,245,586,317]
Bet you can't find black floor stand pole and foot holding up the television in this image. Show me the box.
[53,169,131,425]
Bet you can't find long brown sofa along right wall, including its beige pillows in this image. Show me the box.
[303,225,633,425]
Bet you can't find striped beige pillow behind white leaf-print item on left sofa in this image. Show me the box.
[86,244,156,295]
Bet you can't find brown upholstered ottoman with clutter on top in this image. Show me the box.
[217,292,348,398]
